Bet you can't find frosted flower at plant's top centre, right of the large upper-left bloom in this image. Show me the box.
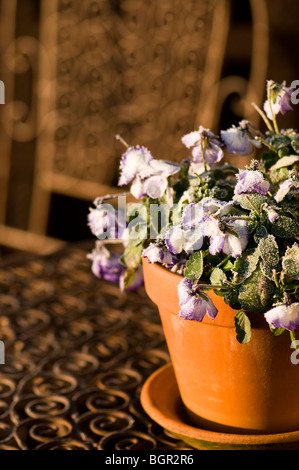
[182,126,223,165]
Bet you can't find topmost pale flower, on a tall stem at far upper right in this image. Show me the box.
[264,80,294,120]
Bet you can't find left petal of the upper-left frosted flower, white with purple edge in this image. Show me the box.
[118,147,153,186]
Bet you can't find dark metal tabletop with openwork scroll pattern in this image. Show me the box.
[0,247,192,450]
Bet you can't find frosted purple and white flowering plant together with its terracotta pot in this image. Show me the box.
[88,81,299,433]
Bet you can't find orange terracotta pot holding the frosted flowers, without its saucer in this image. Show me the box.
[143,259,299,434]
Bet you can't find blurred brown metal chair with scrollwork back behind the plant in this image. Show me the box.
[0,0,269,253]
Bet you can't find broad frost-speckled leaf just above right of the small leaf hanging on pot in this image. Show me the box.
[239,265,274,312]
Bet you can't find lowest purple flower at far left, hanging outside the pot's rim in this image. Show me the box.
[87,244,125,282]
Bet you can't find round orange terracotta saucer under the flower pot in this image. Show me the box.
[141,364,299,450]
